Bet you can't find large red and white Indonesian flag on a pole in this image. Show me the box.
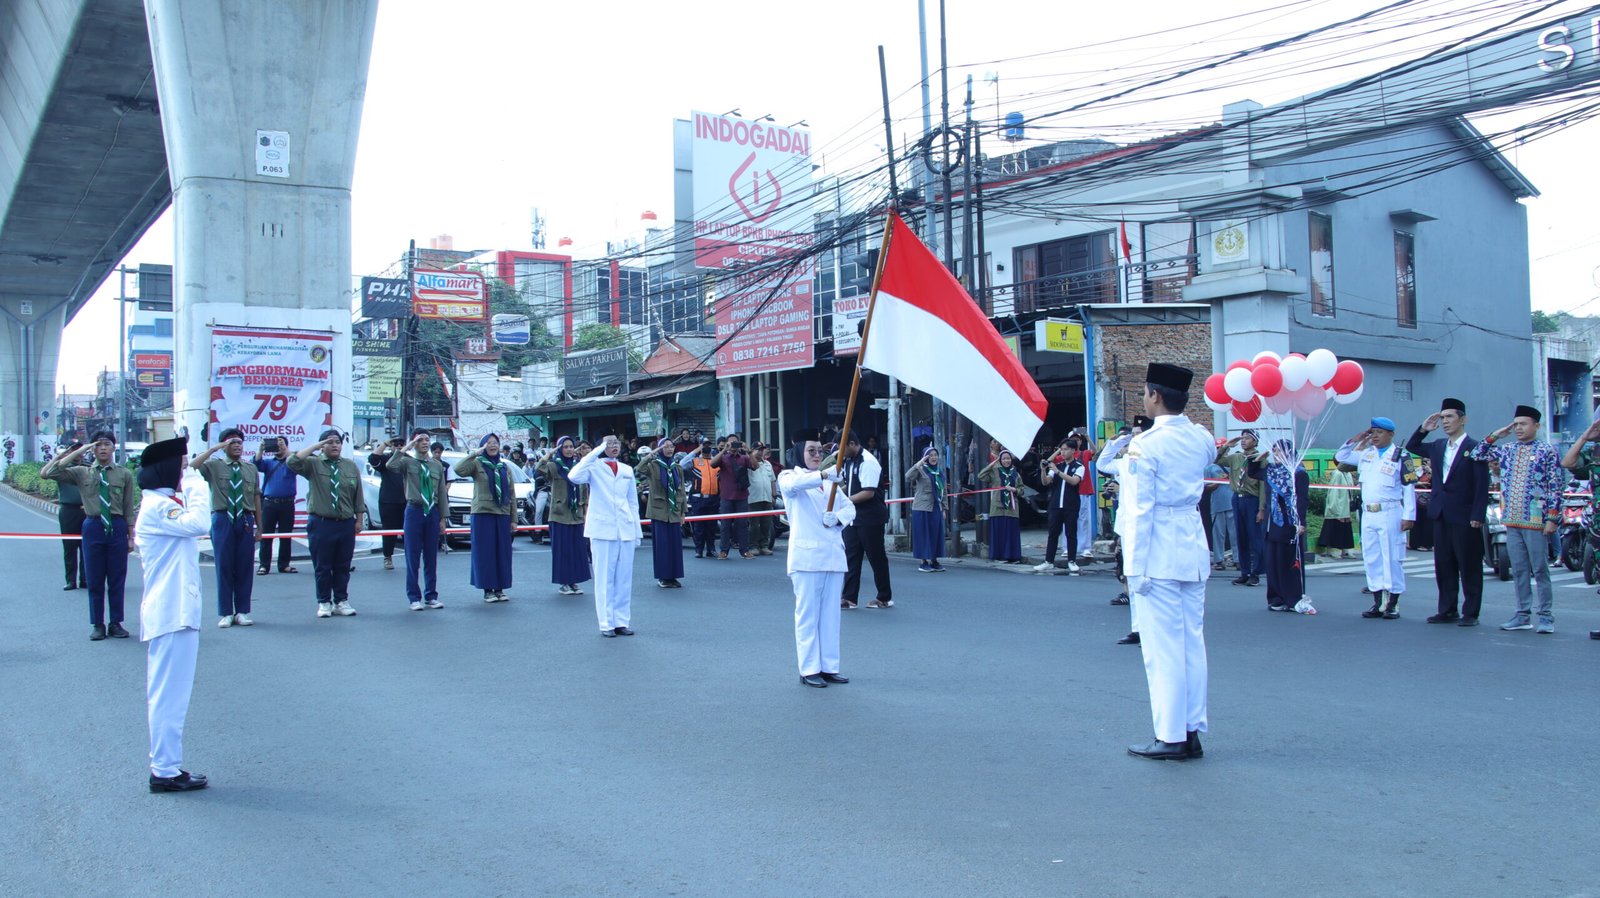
[861,214,1050,453]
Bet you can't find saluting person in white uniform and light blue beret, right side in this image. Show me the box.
[1333,418,1416,621]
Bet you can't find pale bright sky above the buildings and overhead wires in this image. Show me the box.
[58,0,1600,392]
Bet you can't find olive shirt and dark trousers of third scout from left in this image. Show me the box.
[288,434,366,618]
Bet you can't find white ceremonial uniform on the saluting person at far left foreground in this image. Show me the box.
[134,466,211,776]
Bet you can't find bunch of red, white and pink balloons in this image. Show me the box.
[1205,349,1366,424]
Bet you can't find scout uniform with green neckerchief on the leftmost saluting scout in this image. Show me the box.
[43,444,139,639]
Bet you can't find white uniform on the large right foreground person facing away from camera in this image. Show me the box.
[1117,415,1216,743]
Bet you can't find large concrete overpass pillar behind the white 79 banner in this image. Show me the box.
[146,0,378,440]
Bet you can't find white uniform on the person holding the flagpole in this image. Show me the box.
[778,467,856,677]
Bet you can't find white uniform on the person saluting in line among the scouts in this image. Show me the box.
[566,443,643,631]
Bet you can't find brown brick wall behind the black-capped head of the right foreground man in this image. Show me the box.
[1094,323,1214,429]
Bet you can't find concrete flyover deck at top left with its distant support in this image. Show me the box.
[0,0,170,458]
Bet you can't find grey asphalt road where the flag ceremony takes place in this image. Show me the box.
[0,489,1600,898]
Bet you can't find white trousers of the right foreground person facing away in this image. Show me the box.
[1128,578,1206,743]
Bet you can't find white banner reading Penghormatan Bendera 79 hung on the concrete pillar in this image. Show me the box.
[211,327,333,447]
